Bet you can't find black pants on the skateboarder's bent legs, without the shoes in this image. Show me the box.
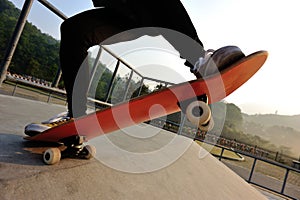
[60,8,203,117]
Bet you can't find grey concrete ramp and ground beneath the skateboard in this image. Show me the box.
[0,95,274,200]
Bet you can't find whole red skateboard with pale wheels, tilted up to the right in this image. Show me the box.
[25,51,268,164]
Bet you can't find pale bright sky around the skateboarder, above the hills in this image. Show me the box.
[6,0,300,115]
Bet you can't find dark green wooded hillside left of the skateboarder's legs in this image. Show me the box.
[0,0,59,81]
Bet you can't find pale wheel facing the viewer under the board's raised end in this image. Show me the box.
[186,101,211,126]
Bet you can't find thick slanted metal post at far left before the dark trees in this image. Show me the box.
[0,0,33,87]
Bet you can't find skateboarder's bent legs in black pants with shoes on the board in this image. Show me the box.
[25,0,244,134]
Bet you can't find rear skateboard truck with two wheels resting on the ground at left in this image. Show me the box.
[43,135,96,165]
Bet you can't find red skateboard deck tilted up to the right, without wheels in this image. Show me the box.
[25,51,268,142]
